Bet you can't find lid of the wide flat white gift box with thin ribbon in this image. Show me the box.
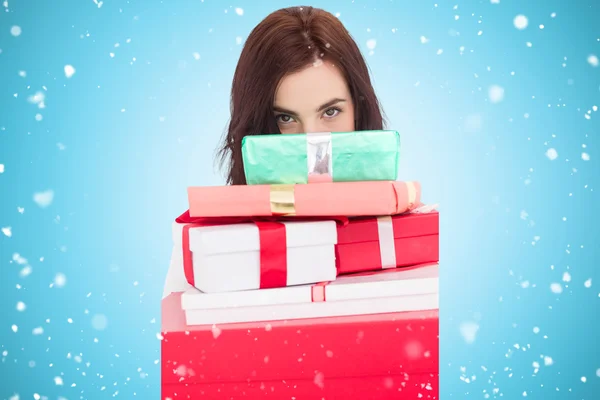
[181,263,439,310]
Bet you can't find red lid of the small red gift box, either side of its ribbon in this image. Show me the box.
[338,211,439,244]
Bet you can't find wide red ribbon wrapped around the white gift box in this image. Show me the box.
[175,210,348,293]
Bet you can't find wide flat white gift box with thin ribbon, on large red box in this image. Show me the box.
[181,264,439,325]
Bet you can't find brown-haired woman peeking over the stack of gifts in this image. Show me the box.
[219,7,384,185]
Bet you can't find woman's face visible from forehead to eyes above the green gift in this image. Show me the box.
[273,61,355,133]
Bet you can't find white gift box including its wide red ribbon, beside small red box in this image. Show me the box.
[173,221,337,293]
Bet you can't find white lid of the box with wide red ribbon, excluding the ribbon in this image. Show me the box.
[173,220,337,255]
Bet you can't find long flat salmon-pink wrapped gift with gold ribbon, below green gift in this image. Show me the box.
[188,181,421,217]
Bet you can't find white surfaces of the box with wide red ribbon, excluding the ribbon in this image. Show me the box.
[173,221,337,293]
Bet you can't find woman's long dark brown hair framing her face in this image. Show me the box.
[218,7,384,185]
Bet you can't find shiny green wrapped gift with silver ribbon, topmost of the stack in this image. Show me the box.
[242,131,400,185]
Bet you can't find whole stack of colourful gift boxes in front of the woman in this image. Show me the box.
[161,131,439,400]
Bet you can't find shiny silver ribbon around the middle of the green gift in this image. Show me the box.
[306,132,333,183]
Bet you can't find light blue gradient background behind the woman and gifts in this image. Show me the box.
[0,0,600,400]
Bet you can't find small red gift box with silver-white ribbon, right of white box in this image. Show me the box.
[336,211,439,275]
